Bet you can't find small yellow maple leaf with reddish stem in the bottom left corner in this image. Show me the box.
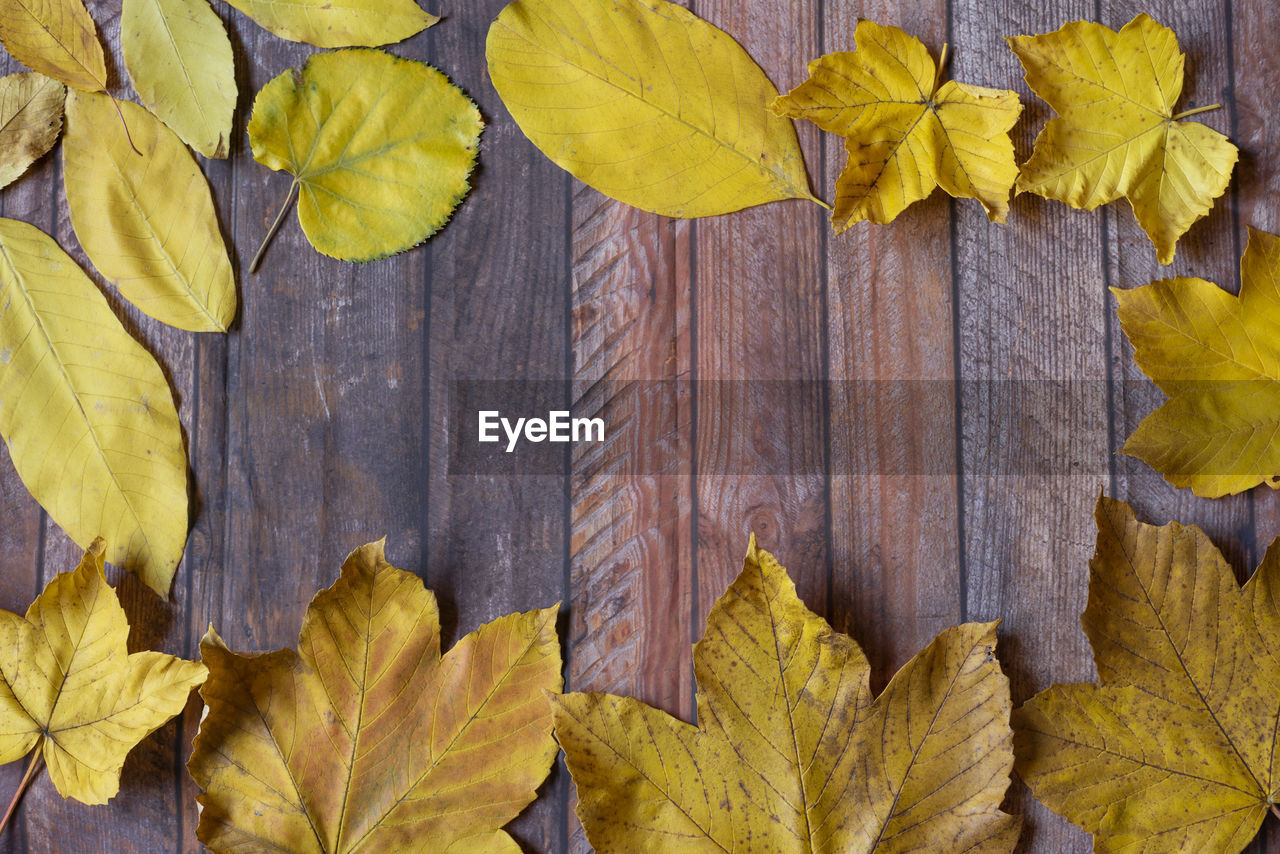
[0,539,207,804]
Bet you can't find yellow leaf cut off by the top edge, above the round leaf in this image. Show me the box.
[227,0,439,47]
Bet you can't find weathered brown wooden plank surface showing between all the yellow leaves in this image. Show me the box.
[0,0,1280,854]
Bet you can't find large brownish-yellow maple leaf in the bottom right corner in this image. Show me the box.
[1014,498,1280,854]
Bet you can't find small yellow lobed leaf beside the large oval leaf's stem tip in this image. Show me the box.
[773,20,1023,233]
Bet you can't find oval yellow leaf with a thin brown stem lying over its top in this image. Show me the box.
[63,92,236,332]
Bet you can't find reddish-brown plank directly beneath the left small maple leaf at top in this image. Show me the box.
[823,0,961,690]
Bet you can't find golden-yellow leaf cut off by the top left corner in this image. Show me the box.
[0,0,106,92]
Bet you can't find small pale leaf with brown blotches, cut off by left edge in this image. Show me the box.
[0,72,67,187]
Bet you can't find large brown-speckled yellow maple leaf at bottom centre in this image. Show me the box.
[554,538,1019,854]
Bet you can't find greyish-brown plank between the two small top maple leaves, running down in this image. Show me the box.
[950,0,1107,851]
